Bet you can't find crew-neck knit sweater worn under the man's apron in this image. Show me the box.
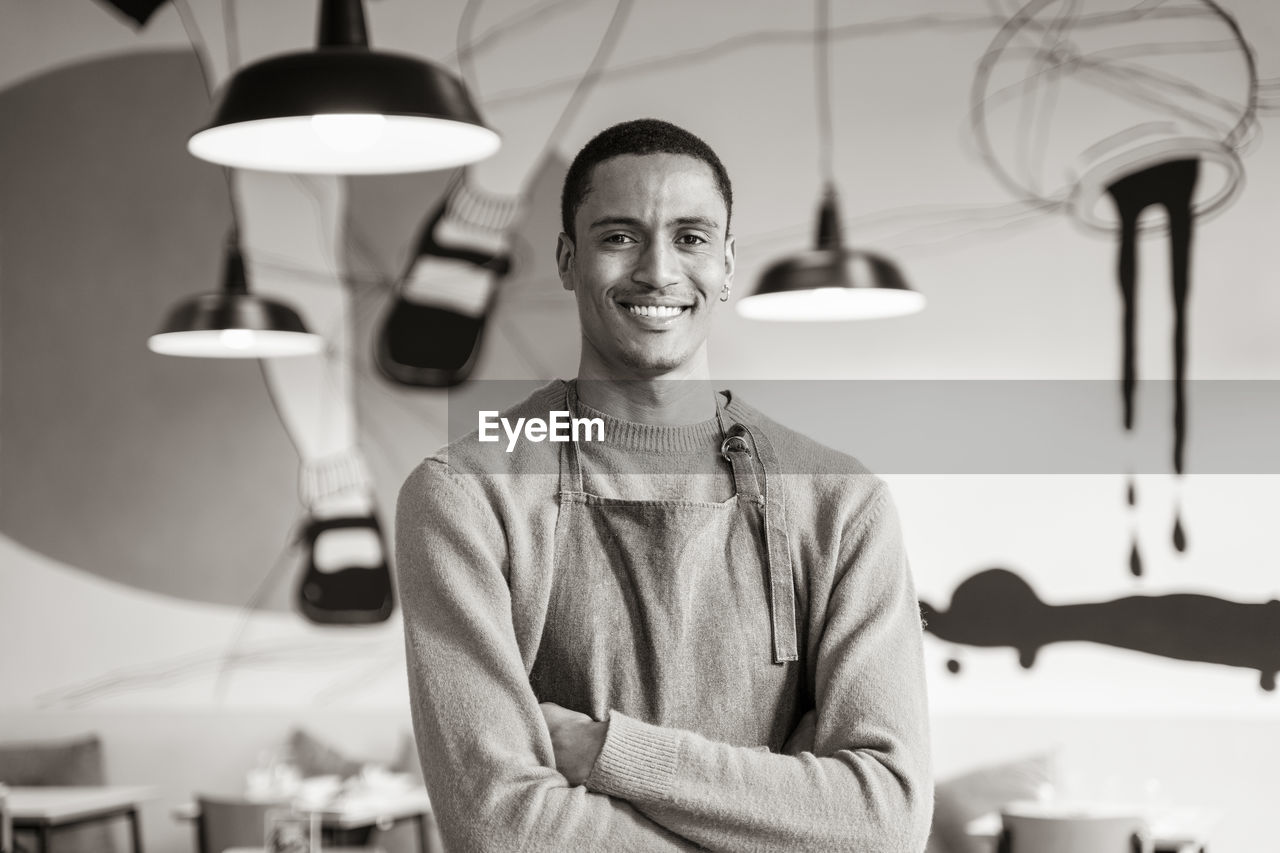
[396,383,933,853]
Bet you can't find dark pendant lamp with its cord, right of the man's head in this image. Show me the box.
[737,0,924,321]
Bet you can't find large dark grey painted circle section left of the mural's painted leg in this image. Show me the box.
[0,51,300,610]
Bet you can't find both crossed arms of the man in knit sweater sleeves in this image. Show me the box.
[396,461,932,853]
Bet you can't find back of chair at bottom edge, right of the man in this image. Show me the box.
[997,812,1152,853]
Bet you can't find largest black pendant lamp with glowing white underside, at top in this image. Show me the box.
[187,0,500,174]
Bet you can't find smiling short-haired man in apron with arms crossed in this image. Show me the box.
[397,119,932,853]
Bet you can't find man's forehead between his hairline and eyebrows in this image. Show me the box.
[579,154,727,223]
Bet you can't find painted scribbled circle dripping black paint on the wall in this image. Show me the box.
[972,0,1258,576]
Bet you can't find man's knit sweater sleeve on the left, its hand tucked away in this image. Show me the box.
[396,460,698,853]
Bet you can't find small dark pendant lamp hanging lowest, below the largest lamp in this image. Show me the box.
[147,232,324,359]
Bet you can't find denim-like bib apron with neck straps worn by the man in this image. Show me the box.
[529,383,805,749]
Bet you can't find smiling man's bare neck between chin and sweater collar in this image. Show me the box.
[577,360,716,427]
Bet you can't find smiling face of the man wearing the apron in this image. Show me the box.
[557,154,733,377]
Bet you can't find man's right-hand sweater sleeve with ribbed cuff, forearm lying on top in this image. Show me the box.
[586,485,933,853]
